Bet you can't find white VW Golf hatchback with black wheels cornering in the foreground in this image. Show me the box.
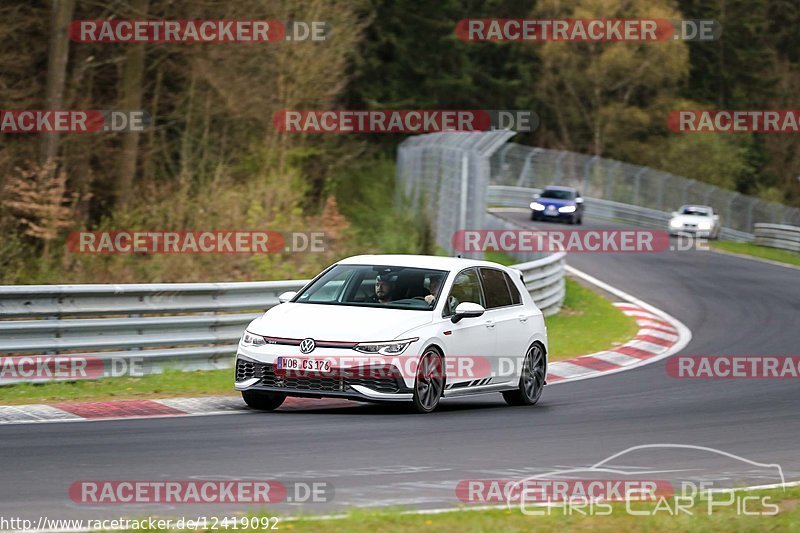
[236,255,547,413]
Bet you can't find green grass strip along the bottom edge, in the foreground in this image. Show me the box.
[272,488,800,533]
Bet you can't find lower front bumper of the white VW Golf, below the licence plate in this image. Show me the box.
[235,354,412,402]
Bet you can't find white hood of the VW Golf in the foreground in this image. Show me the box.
[247,303,433,342]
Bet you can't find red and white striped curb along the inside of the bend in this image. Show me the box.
[0,265,692,424]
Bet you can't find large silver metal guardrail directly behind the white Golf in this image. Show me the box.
[0,253,565,385]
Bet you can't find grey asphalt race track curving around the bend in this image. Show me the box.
[0,213,800,518]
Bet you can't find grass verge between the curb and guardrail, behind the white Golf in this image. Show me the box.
[0,256,637,405]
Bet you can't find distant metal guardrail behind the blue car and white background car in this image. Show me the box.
[487,185,758,241]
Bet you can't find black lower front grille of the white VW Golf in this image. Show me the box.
[236,359,404,393]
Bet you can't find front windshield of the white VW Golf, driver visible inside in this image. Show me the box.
[292,264,447,311]
